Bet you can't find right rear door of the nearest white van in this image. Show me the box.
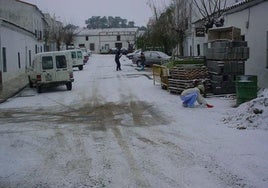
[55,55,69,81]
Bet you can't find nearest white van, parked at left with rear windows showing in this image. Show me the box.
[27,51,74,93]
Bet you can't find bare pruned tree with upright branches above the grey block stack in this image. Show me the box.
[193,0,227,30]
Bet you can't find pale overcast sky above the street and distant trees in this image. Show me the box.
[22,0,170,27]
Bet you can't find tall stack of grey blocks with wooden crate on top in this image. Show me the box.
[204,27,249,94]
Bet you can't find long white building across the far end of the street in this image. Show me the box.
[74,28,138,53]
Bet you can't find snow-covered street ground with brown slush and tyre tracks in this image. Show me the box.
[0,55,268,188]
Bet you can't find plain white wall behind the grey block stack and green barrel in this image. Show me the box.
[225,1,268,88]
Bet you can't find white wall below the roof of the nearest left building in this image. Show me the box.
[0,21,36,86]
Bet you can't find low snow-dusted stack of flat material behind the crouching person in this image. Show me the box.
[168,66,208,94]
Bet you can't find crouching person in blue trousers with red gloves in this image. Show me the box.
[181,84,213,108]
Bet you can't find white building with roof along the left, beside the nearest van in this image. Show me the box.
[0,0,46,89]
